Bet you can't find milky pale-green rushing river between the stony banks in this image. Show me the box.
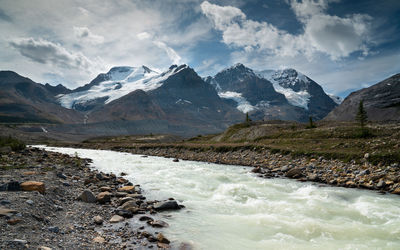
[38,147,400,250]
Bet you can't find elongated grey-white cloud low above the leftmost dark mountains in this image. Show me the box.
[10,38,93,71]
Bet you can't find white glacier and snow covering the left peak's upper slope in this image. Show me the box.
[57,66,188,111]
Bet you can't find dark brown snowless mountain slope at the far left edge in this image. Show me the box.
[0,71,83,123]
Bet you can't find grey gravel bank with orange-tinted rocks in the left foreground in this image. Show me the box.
[0,148,182,249]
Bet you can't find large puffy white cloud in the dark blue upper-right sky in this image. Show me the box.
[200,0,371,60]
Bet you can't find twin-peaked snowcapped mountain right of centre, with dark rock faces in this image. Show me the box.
[205,63,337,121]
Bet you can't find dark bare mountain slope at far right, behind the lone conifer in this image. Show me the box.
[325,74,400,121]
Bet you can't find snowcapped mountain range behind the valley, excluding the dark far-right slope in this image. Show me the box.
[0,64,397,136]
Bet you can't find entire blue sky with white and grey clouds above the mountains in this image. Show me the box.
[0,0,400,96]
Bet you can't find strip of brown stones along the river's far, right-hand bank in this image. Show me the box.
[113,145,400,194]
